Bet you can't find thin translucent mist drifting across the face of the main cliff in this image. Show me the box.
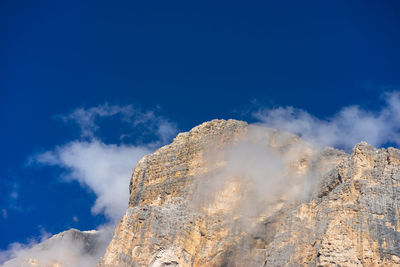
[194,125,344,220]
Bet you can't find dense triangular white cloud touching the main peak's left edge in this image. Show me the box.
[36,139,151,221]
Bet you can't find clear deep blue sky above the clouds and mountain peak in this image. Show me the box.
[0,0,400,249]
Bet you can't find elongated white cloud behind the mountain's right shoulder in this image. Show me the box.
[254,92,400,150]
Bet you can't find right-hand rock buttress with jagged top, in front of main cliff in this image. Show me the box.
[265,143,400,266]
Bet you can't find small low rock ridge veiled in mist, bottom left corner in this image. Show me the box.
[3,229,104,267]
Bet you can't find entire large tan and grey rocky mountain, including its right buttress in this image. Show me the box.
[98,120,400,267]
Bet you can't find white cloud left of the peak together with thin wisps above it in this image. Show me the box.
[34,103,177,221]
